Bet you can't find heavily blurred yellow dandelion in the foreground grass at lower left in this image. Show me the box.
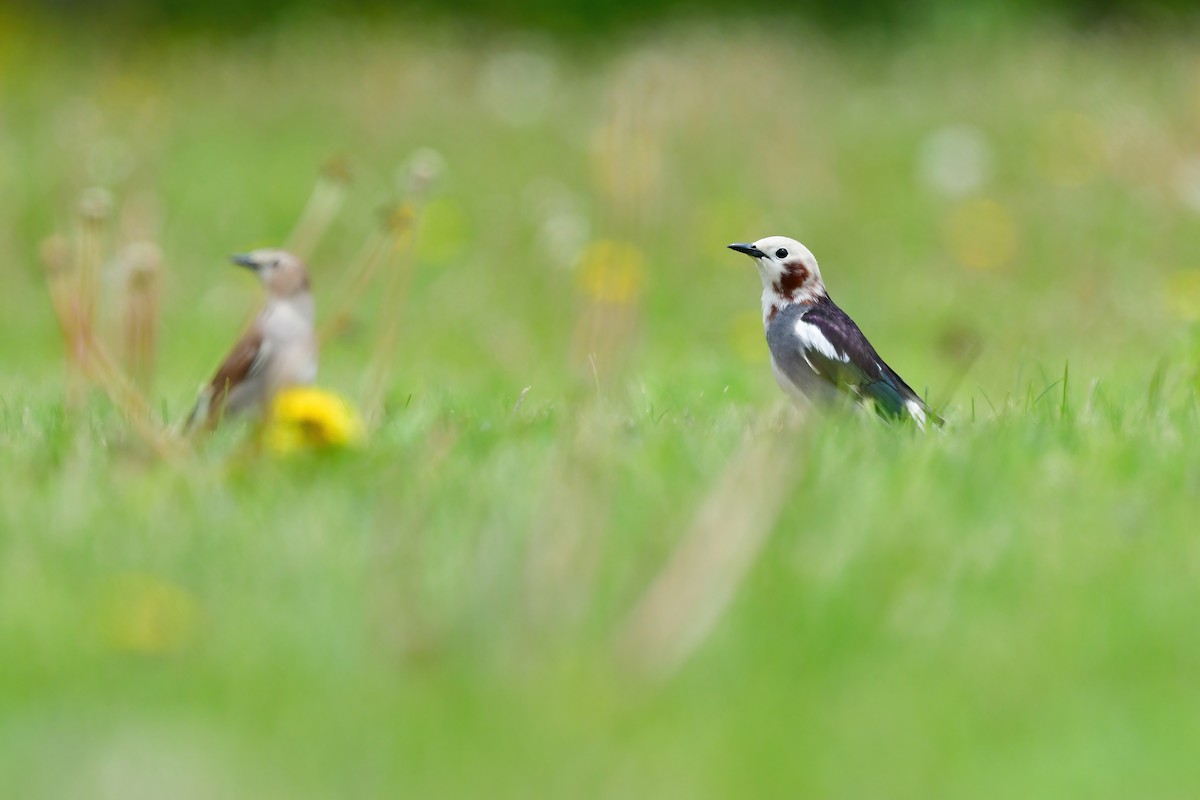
[102,575,200,655]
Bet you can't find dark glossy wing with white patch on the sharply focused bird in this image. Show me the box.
[794,296,941,425]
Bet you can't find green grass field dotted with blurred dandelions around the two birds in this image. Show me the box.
[0,19,1200,799]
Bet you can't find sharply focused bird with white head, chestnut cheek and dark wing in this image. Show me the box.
[728,236,943,429]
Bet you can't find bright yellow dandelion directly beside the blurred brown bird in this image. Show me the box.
[265,387,362,456]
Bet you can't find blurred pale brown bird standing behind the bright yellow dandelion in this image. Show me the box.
[187,249,318,429]
